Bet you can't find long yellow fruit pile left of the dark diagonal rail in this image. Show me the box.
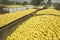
[0,9,36,28]
